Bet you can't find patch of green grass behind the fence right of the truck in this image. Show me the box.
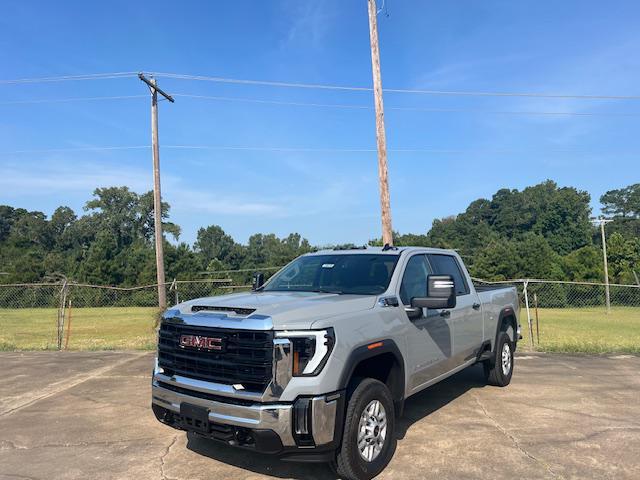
[520,307,640,354]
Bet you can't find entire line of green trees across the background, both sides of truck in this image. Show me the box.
[0,181,640,286]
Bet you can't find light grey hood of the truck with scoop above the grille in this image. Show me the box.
[174,292,377,330]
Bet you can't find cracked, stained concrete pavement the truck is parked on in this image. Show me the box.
[0,352,640,480]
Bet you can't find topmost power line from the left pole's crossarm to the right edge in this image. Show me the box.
[155,73,640,100]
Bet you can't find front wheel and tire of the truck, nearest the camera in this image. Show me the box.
[333,378,397,480]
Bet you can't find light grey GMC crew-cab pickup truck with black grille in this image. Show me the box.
[152,246,520,479]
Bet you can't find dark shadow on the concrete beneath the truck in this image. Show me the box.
[187,365,486,480]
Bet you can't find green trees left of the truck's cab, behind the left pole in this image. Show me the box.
[0,187,311,284]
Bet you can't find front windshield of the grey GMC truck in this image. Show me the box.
[263,254,398,295]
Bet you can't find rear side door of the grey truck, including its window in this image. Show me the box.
[428,253,484,365]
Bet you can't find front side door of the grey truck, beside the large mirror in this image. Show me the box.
[399,254,453,391]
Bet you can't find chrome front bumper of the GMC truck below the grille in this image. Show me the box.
[152,375,342,448]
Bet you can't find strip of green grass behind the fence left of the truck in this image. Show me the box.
[0,307,158,350]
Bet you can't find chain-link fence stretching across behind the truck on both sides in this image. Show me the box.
[0,274,640,353]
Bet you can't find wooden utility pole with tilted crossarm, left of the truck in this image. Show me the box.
[138,73,174,309]
